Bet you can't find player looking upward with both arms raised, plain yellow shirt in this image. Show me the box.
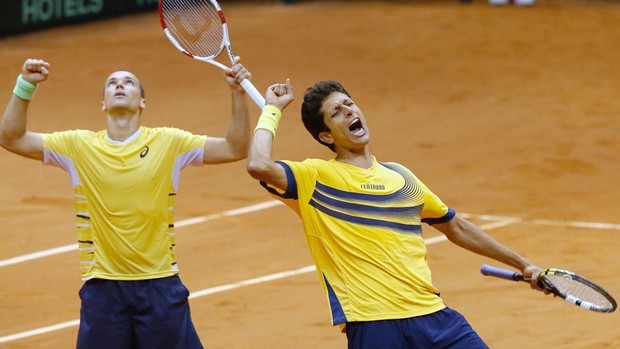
[0,57,251,349]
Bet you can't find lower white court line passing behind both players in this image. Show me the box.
[0,223,484,343]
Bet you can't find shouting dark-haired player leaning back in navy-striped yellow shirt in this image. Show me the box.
[247,80,540,349]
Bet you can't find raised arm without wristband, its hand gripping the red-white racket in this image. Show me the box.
[203,57,252,164]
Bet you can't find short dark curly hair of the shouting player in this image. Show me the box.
[301,80,351,151]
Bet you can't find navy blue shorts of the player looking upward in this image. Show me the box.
[77,276,202,349]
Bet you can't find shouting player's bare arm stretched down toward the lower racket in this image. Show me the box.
[433,215,541,289]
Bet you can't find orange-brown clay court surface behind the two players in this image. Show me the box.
[0,0,620,349]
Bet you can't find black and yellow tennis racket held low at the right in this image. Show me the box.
[480,264,617,313]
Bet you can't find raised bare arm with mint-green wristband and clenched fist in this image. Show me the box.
[0,59,50,160]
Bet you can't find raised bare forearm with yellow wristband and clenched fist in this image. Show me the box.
[247,79,294,190]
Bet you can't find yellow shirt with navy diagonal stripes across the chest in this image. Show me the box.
[263,159,454,325]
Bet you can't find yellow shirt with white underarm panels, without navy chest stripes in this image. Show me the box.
[43,127,206,280]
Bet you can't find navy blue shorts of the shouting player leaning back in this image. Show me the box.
[346,308,489,349]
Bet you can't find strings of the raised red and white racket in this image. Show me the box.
[162,0,224,57]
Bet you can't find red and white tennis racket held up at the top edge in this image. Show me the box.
[159,0,265,109]
